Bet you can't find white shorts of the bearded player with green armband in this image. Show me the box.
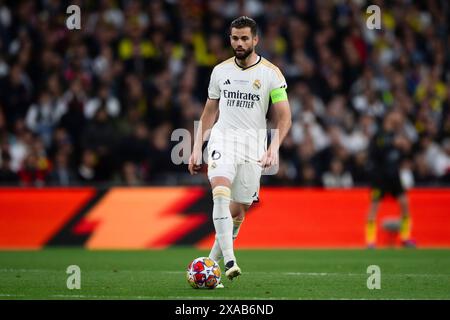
[208,141,262,205]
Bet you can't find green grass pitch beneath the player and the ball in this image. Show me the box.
[0,248,450,299]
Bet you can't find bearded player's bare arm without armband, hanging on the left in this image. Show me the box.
[188,98,219,174]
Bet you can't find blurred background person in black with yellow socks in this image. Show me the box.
[366,110,415,248]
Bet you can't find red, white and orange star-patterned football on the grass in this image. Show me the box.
[186,257,221,289]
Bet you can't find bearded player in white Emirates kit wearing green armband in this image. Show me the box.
[189,16,291,280]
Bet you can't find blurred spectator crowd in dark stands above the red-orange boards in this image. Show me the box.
[0,0,450,187]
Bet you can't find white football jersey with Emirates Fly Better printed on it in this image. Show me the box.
[208,56,287,161]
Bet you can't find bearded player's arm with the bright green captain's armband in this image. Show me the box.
[261,87,292,168]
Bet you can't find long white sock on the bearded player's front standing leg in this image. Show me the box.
[211,186,236,263]
